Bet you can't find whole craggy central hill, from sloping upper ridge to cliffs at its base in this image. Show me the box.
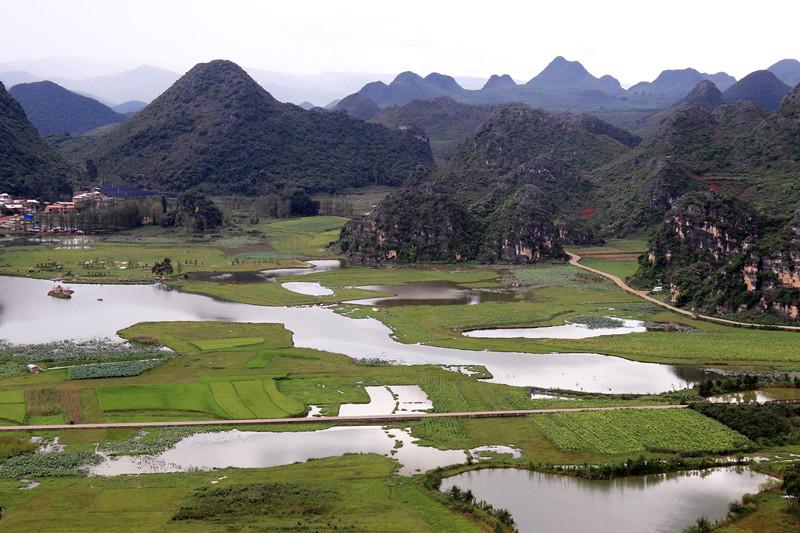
[341,106,630,262]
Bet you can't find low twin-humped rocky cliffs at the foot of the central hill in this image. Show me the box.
[339,187,565,263]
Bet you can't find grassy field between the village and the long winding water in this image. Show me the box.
[0,217,346,283]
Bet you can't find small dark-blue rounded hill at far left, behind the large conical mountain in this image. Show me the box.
[9,81,125,136]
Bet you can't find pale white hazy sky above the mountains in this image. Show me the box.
[0,0,800,83]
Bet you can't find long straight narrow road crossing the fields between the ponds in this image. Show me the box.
[0,405,687,432]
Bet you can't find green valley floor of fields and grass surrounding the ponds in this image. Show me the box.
[0,217,800,531]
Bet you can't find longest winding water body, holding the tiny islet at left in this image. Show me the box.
[0,276,718,393]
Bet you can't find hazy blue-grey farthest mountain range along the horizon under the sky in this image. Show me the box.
[0,57,800,111]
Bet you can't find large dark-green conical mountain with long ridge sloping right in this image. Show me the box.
[86,61,433,194]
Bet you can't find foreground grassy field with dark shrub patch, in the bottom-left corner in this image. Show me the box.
[0,455,486,532]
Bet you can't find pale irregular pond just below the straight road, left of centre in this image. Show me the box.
[91,426,476,476]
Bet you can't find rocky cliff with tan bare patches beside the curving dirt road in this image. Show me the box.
[635,193,800,321]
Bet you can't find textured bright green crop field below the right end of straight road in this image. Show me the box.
[531,409,749,454]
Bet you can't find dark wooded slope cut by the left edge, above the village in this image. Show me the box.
[0,83,79,200]
